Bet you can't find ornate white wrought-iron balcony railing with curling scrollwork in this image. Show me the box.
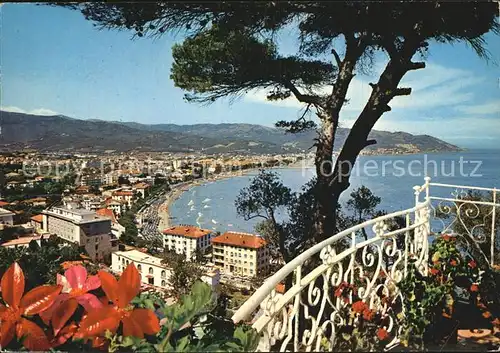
[232,178,500,351]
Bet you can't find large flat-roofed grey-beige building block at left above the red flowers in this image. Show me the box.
[42,207,118,261]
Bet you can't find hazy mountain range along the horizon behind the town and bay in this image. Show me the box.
[0,111,460,154]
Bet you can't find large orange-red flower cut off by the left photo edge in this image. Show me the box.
[0,262,62,351]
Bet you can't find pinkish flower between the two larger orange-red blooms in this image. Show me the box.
[40,265,103,335]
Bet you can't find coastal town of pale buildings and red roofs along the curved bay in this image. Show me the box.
[0,152,310,302]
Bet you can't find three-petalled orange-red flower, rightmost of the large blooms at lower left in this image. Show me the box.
[75,263,160,338]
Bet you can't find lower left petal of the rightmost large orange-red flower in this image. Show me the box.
[75,306,120,338]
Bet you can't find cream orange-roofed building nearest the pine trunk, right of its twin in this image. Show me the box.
[212,232,270,277]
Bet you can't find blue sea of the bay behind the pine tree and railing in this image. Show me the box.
[170,150,500,233]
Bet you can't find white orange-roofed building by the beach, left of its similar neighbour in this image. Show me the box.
[163,225,213,260]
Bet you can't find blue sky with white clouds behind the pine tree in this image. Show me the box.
[0,4,500,148]
